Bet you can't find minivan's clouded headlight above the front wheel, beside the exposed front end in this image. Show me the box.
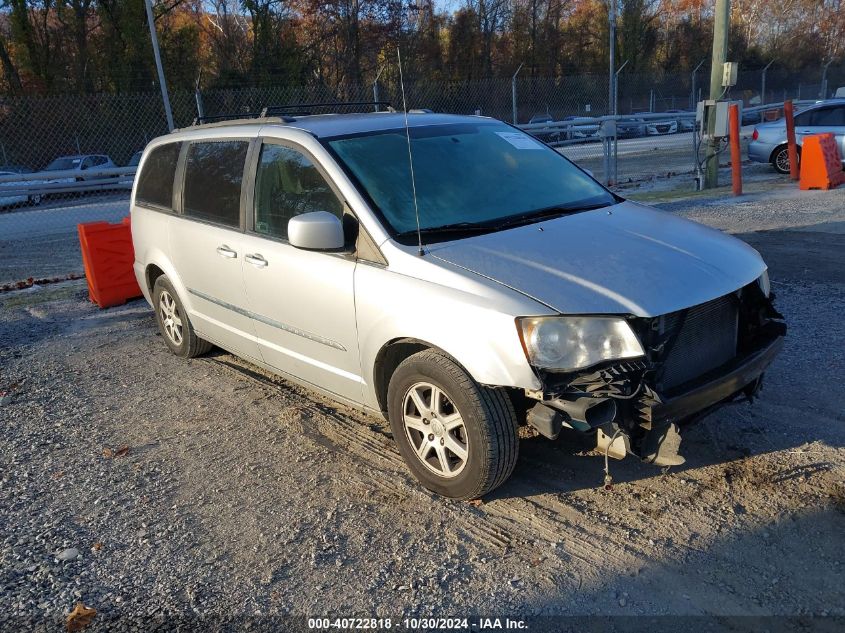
[516,317,644,371]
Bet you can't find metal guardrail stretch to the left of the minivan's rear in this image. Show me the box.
[0,167,137,199]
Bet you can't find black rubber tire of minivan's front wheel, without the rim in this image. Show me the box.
[387,350,519,499]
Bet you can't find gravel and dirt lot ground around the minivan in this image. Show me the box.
[0,181,845,630]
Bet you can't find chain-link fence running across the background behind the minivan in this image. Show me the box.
[0,66,845,286]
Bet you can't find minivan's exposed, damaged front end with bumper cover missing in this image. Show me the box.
[526,284,786,465]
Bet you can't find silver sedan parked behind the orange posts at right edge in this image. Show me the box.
[748,99,845,174]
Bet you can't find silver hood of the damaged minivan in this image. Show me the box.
[428,202,766,317]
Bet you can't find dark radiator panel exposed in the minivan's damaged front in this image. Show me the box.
[661,295,739,390]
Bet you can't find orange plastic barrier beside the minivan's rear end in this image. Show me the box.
[76,218,141,308]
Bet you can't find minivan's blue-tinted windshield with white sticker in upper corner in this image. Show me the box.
[328,121,616,243]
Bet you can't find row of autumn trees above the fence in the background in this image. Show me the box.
[0,0,845,95]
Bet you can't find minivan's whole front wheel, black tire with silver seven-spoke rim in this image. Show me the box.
[387,350,519,499]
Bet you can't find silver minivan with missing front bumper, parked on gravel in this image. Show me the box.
[131,112,786,499]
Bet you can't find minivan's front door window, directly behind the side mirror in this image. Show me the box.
[255,145,343,239]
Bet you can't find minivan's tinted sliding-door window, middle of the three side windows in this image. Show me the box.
[182,141,249,226]
